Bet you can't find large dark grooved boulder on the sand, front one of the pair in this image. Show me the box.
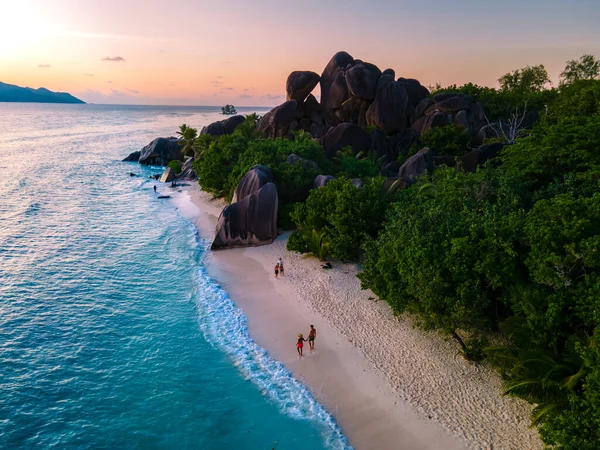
[211,183,279,250]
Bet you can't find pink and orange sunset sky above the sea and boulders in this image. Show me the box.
[0,0,600,106]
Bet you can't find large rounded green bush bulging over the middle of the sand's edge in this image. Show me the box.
[359,167,523,332]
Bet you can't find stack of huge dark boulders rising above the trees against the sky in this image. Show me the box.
[259,51,486,153]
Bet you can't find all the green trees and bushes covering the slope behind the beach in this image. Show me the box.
[180,55,600,450]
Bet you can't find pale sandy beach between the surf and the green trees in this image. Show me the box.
[170,184,542,450]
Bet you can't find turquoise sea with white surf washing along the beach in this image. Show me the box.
[0,104,349,450]
